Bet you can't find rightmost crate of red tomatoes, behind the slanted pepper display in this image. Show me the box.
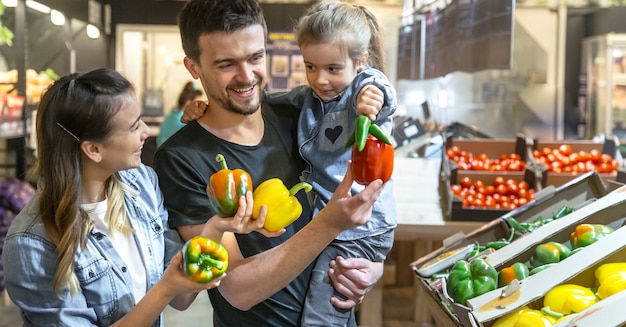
[532,139,622,190]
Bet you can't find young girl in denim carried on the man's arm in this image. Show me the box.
[265,1,396,326]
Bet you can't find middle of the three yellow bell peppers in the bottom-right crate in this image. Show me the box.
[543,284,598,315]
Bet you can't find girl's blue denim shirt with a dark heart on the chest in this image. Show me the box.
[265,67,397,240]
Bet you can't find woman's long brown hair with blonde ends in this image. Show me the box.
[29,68,134,295]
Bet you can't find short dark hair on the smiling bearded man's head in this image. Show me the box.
[177,0,267,61]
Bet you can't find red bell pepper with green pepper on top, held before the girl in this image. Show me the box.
[348,116,394,185]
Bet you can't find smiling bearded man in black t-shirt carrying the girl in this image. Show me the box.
[155,0,383,326]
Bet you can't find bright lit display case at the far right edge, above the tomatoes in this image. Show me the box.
[581,33,626,152]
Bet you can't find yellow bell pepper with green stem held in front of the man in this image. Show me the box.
[252,178,313,232]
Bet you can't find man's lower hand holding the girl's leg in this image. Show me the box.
[328,256,384,310]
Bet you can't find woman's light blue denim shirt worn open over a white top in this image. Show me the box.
[2,165,182,326]
